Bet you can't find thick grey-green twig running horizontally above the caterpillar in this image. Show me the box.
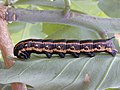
[6,8,120,38]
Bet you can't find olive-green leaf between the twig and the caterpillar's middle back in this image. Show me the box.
[43,23,100,40]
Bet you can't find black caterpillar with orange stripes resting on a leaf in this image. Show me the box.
[14,37,117,59]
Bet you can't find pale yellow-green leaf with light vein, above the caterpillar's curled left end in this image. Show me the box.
[9,23,46,43]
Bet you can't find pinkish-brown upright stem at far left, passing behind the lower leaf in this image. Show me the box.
[0,5,27,90]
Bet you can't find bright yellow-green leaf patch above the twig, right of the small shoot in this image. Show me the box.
[71,0,108,17]
